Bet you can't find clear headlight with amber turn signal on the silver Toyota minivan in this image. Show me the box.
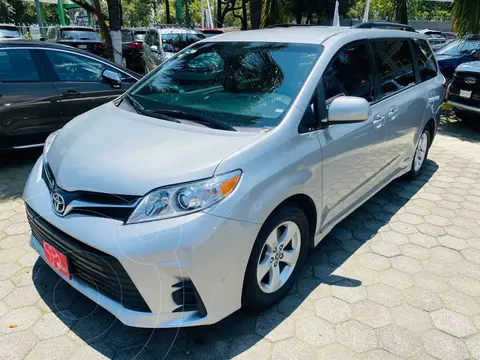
[127,170,242,224]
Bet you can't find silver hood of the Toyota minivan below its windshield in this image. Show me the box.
[47,103,263,195]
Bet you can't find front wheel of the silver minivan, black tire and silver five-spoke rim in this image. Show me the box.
[242,203,310,310]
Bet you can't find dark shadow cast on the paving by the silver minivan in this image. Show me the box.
[32,160,438,360]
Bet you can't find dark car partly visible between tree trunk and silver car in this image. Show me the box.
[122,28,147,72]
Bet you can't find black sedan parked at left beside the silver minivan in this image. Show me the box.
[0,40,141,150]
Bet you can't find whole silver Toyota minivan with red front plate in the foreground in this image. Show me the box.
[24,21,444,327]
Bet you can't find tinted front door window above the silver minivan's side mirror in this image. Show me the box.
[323,44,374,104]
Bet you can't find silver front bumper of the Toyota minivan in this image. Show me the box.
[24,159,261,327]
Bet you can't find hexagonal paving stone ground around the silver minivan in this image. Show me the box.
[0,115,480,360]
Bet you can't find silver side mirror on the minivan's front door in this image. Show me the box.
[328,96,372,123]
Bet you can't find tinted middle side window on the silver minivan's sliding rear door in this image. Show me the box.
[373,39,415,96]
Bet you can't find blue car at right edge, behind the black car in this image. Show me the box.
[435,35,480,79]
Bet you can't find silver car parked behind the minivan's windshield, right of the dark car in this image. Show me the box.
[143,25,205,73]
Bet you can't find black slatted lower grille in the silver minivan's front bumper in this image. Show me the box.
[27,205,151,312]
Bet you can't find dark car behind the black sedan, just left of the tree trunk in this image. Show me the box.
[47,26,106,56]
